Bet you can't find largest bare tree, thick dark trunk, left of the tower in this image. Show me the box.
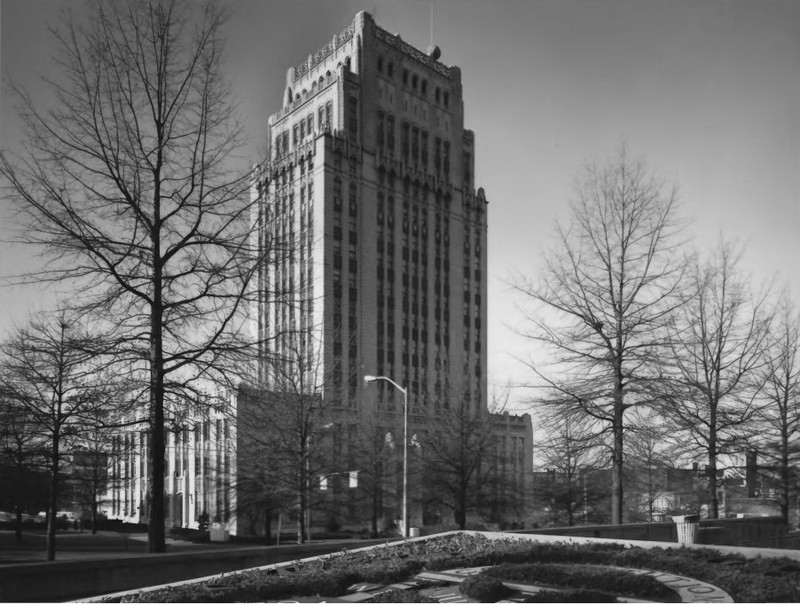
[0,0,269,552]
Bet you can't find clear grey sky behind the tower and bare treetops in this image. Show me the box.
[0,0,800,406]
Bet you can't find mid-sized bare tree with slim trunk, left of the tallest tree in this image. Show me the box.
[0,312,105,561]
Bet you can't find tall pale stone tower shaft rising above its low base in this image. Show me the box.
[254,12,487,446]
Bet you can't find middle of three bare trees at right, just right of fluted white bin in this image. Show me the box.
[661,241,771,519]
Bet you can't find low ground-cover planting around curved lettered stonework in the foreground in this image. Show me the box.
[114,533,800,602]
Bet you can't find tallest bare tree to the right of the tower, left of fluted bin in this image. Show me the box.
[516,148,684,524]
